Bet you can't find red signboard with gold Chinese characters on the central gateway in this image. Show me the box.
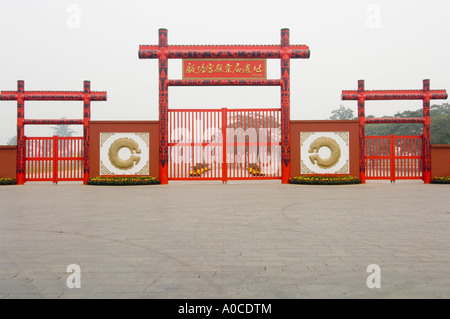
[183,59,267,80]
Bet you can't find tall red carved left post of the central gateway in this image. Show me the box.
[158,29,169,184]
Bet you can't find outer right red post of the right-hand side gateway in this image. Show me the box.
[422,80,431,184]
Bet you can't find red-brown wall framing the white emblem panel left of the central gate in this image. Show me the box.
[89,121,159,177]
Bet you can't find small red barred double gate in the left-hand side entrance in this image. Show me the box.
[24,136,84,183]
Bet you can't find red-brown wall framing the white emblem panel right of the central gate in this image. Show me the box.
[290,120,359,177]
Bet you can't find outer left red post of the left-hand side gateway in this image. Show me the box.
[16,80,25,185]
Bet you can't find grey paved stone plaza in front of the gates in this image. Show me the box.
[0,181,450,299]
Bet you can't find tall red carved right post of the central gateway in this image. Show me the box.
[281,29,291,184]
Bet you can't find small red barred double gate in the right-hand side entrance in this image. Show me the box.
[365,135,423,182]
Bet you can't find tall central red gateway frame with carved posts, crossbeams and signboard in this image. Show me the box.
[139,29,310,184]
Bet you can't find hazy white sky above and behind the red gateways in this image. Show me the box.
[0,0,450,144]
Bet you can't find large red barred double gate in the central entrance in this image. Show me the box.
[168,108,281,182]
